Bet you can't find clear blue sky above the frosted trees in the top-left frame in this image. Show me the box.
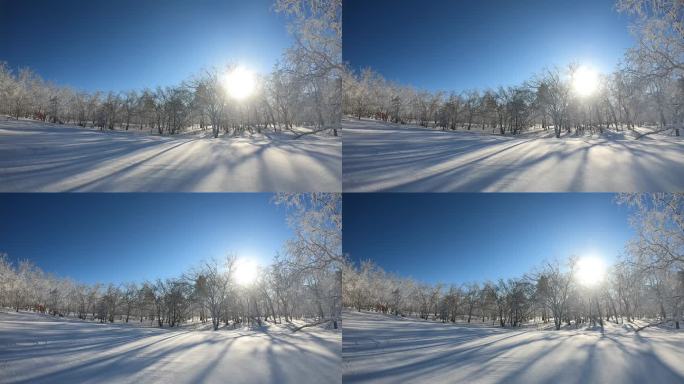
[0,0,291,91]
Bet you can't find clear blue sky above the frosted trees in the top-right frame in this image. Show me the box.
[343,0,634,91]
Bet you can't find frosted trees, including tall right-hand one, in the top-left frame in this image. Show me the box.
[0,0,341,137]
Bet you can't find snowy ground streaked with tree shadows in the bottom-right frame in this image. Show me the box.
[342,311,684,384]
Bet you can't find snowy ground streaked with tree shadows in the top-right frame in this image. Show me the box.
[342,119,684,192]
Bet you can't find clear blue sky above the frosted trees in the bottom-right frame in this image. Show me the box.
[343,193,633,284]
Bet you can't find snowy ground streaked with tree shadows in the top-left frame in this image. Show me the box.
[0,117,342,192]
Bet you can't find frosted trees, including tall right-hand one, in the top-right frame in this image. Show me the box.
[343,0,684,137]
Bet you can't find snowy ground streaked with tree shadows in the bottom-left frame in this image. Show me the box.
[0,311,342,383]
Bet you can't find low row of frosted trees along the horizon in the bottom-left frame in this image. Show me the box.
[0,255,336,329]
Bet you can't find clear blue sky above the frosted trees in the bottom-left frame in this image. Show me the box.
[0,193,292,283]
